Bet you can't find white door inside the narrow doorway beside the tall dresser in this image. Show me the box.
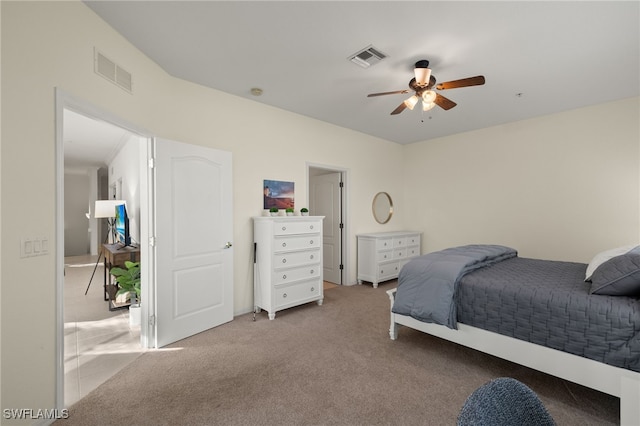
[309,173,342,284]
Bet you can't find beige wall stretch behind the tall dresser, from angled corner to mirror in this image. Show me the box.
[158,80,403,312]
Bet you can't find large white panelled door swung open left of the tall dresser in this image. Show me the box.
[154,140,233,347]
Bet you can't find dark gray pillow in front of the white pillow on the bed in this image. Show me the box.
[591,247,640,296]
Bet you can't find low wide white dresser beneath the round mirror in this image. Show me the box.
[356,231,420,288]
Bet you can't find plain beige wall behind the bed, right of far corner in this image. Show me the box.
[404,97,640,263]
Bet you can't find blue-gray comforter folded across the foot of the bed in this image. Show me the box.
[391,244,518,329]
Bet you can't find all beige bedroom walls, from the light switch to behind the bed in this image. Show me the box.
[0,1,640,420]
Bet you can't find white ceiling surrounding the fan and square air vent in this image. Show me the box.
[67,1,640,166]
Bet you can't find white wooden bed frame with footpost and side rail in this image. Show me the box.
[387,288,640,426]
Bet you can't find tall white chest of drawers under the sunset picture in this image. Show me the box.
[253,216,324,320]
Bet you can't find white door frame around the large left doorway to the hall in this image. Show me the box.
[55,88,153,410]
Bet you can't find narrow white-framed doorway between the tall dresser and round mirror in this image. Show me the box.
[307,165,347,285]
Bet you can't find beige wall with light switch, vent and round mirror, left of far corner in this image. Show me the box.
[0,1,403,416]
